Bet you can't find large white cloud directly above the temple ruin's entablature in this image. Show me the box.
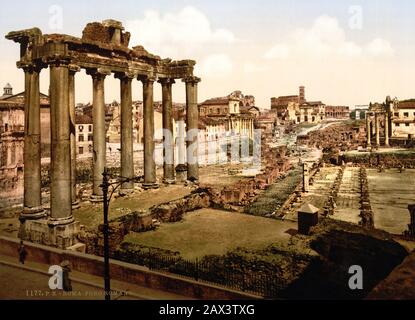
[126,6,236,59]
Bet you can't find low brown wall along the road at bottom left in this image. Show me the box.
[0,237,259,300]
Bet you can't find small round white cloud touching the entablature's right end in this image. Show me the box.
[195,54,233,78]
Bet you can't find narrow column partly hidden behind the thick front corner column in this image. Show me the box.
[68,65,81,209]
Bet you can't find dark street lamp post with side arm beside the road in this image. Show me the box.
[100,167,141,301]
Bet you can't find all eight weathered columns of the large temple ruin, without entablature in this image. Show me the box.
[21,60,200,225]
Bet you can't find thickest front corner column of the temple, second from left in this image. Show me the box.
[48,61,74,225]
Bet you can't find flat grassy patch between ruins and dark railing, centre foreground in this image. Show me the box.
[124,209,296,259]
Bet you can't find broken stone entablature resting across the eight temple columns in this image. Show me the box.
[6,20,196,79]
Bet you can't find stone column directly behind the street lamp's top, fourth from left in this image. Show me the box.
[87,69,111,202]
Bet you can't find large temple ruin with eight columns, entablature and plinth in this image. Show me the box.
[6,20,200,248]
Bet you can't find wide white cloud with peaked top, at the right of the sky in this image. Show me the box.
[264,15,394,59]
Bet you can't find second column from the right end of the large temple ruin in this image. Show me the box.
[159,78,176,184]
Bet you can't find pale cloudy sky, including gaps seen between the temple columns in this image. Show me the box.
[0,0,415,108]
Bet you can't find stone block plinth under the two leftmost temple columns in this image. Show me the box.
[20,217,80,249]
